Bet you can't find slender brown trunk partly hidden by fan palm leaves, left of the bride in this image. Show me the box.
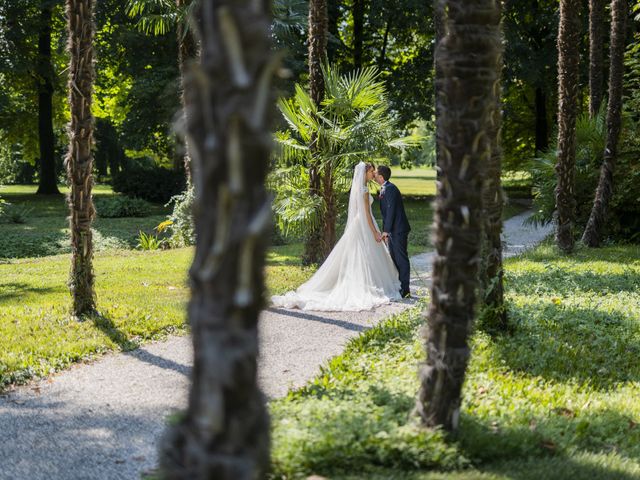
[303,0,327,264]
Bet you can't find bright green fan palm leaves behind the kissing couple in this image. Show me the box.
[270,66,420,233]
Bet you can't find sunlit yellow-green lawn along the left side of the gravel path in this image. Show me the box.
[0,246,313,390]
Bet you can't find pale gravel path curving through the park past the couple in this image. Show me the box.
[0,212,550,480]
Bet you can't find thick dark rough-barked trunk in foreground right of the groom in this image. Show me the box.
[416,0,500,430]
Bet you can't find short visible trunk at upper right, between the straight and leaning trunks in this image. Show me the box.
[589,0,605,118]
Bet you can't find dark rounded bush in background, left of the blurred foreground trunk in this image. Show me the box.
[112,165,186,203]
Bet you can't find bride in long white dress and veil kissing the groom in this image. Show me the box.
[271,162,400,311]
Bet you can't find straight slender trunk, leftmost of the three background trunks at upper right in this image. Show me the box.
[556,0,582,253]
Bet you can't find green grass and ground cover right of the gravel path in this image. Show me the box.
[271,244,640,480]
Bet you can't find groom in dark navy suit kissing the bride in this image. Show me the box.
[375,165,411,298]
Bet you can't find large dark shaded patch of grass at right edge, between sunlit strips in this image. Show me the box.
[493,302,640,390]
